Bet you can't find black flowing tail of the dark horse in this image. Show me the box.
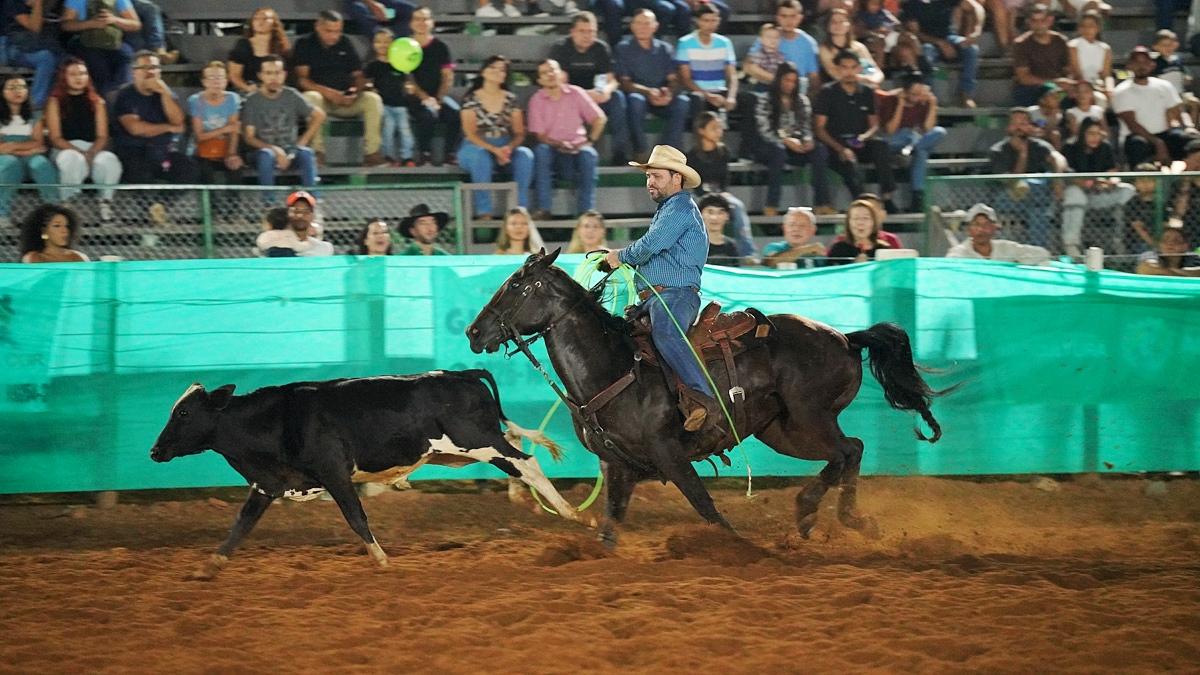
[846,323,953,443]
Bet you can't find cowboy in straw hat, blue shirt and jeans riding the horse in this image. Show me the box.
[605,145,720,431]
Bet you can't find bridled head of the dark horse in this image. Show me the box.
[467,249,568,354]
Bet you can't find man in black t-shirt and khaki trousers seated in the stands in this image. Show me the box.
[292,10,386,167]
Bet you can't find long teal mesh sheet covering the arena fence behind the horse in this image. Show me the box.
[0,256,1200,492]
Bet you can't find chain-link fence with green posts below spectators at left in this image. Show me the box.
[0,183,463,262]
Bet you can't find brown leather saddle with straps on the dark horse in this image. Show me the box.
[629,303,773,437]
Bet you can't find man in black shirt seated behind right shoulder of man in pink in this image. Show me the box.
[550,12,641,166]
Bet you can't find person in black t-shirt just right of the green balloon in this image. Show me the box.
[408,7,462,166]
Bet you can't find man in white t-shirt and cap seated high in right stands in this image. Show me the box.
[1112,47,1200,167]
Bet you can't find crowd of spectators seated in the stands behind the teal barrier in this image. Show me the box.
[0,0,1200,267]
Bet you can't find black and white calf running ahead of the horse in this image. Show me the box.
[150,370,594,572]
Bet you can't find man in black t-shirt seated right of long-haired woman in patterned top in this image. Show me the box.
[812,49,898,213]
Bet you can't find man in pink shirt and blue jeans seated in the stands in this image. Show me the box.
[529,59,608,220]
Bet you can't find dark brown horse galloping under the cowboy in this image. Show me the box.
[467,251,941,545]
